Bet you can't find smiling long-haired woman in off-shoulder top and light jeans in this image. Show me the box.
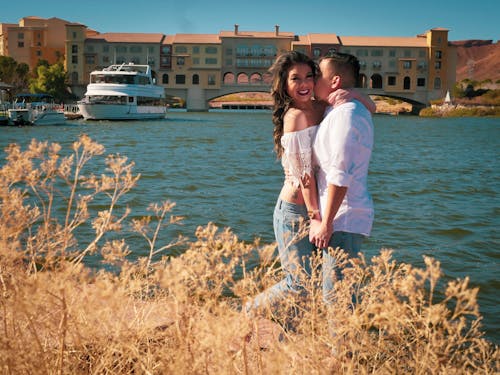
[245,51,374,320]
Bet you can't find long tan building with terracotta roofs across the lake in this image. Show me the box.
[0,17,456,109]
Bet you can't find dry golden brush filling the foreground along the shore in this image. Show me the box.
[0,136,499,374]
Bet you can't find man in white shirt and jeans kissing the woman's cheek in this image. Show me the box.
[310,53,373,302]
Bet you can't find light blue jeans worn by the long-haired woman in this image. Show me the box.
[245,199,315,312]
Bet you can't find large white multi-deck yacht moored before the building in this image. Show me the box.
[78,63,167,120]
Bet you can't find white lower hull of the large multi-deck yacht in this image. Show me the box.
[78,103,167,120]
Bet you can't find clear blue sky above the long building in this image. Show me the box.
[0,0,500,42]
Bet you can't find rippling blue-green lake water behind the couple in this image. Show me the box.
[0,111,500,343]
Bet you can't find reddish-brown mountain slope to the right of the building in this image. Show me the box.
[450,40,500,83]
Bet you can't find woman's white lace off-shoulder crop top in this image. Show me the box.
[281,125,318,186]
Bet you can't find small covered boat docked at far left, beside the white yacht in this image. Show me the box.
[7,94,66,125]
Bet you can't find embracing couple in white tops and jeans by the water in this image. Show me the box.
[245,51,375,320]
